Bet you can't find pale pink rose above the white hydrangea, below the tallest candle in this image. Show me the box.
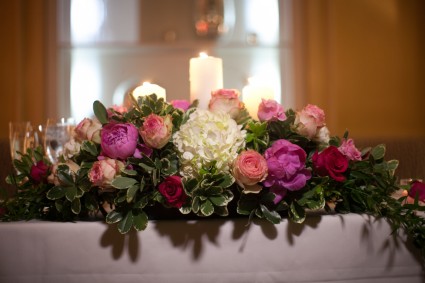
[208,89,244,119]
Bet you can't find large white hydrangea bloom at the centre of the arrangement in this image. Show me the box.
[173,109,246,178]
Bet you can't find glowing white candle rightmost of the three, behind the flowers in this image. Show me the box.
[242,78,274,120]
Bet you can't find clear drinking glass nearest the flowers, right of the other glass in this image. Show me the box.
[44,118,75,163]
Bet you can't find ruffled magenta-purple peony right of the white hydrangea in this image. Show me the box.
[263,139,311,203]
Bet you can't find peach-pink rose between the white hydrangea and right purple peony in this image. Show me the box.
[232,150,267,193]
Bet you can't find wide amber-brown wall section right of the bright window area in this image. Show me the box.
[295,0,425,138]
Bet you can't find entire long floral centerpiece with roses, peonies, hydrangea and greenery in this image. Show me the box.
[1,89,425,260]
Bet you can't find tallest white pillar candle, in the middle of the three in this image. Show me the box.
[189,52,223,109]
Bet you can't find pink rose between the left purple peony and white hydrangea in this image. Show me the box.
[139,114,173,149]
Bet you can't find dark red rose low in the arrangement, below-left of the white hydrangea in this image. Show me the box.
[158,176,187,208]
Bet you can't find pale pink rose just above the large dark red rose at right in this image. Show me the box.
[295,104,325,139]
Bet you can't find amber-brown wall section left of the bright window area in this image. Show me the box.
[0,0,56,139]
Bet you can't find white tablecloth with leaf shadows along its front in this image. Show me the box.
[0,214,425,283]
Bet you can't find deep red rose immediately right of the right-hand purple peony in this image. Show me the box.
[312,146,348,182]
